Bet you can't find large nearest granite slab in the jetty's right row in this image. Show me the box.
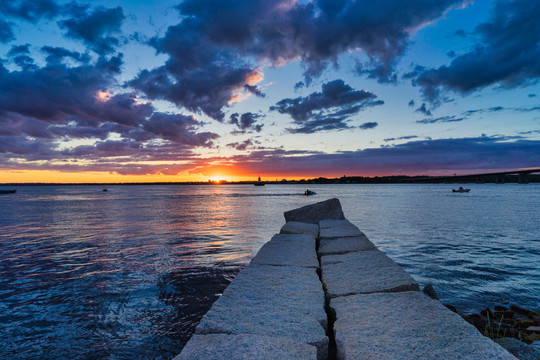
[330,291,515,360]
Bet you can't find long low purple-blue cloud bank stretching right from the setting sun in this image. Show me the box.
[199,136,540,177]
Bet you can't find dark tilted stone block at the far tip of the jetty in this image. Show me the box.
[283,198,345,224]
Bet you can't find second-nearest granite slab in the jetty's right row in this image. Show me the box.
[321,250,420,298]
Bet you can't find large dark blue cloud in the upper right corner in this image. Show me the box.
[414,0,540,104]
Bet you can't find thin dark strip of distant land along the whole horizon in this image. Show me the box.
[0,174,540,186]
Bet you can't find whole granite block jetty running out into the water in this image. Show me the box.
[174,199,515,360]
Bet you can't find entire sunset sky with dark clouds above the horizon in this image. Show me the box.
[0,0,540,183]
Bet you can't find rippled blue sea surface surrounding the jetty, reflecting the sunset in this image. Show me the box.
[0,184,540,359]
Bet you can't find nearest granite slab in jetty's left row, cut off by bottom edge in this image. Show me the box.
[173,334,317,360]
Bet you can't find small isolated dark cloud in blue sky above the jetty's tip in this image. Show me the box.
[270,79,384,133]
